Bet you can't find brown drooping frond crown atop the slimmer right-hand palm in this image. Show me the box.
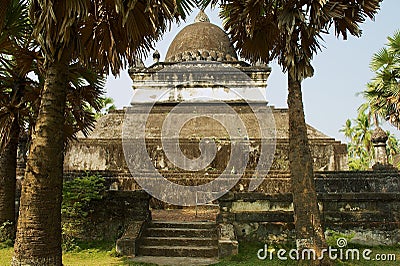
[212,0,380,80]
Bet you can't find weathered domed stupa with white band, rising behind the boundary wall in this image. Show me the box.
[65,11,347,189]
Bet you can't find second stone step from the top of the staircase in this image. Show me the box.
[145,227,217,238]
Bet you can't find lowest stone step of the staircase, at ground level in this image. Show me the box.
[139,246,218,258]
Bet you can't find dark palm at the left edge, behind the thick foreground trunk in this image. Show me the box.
[0,68,40,241]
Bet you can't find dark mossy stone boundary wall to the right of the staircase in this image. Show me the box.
[218,171,400,245]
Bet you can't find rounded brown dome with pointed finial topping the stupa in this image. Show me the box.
[165,11,237,62]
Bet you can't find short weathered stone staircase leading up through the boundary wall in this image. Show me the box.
[138,221,218,258]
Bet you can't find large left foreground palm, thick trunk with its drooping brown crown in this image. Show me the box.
[12,0,195,265]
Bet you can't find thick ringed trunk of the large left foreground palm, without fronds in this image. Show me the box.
[12,62,68,266]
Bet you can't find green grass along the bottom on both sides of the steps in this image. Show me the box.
[0,240,400,266]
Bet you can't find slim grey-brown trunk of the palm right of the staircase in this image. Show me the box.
[288,71,326,263]
